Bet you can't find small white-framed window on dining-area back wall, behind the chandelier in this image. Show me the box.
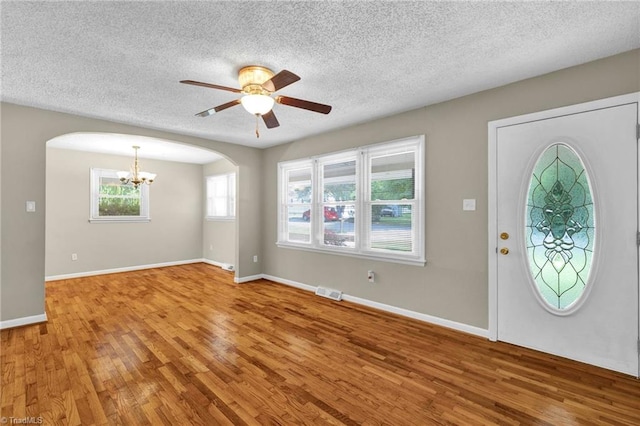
[89,169,150,222]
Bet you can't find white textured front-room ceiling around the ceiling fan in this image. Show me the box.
[0,1,640,147]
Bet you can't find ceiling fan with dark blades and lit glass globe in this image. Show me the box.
[180,65,331,137]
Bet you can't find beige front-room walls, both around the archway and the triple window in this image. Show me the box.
[0,50,640,328]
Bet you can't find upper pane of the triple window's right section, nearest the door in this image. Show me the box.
[371,151,415,200]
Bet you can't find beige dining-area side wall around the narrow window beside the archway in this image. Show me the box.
[202,159,238,265]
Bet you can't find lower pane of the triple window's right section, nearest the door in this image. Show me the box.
[370,204,413,252]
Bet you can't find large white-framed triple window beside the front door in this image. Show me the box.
[278,136,424,264]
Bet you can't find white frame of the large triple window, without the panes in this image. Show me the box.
[276,135,426,266]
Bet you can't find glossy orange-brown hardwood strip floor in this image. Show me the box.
[0,264,640,425]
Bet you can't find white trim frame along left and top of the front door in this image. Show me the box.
[488,92,640,342]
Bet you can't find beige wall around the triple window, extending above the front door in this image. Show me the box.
[262,50,640,329]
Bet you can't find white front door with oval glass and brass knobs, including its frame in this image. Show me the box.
[489,96,640,376]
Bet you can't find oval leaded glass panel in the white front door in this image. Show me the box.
[525,143,596,310]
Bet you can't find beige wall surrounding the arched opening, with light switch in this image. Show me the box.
[0,103,262,321]
